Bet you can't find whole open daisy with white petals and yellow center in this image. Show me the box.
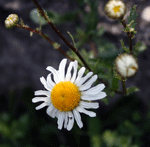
[32,59,106,130]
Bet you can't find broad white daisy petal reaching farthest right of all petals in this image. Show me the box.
[81,92,107,101]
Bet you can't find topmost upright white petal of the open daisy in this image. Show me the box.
[59,59,67,81]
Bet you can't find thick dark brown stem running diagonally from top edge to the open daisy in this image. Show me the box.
[32,0,91,71]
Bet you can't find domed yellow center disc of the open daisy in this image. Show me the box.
[51,81,81,111]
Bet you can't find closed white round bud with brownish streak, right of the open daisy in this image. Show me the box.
[115,53,138,78]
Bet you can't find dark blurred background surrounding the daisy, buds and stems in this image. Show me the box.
[0,0,150,147]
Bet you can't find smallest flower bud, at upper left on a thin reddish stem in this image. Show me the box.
[5,14,19,29]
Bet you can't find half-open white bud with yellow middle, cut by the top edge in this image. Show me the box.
[105,0,126,19]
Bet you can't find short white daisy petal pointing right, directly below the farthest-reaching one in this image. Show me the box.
[79,101,99,109]
